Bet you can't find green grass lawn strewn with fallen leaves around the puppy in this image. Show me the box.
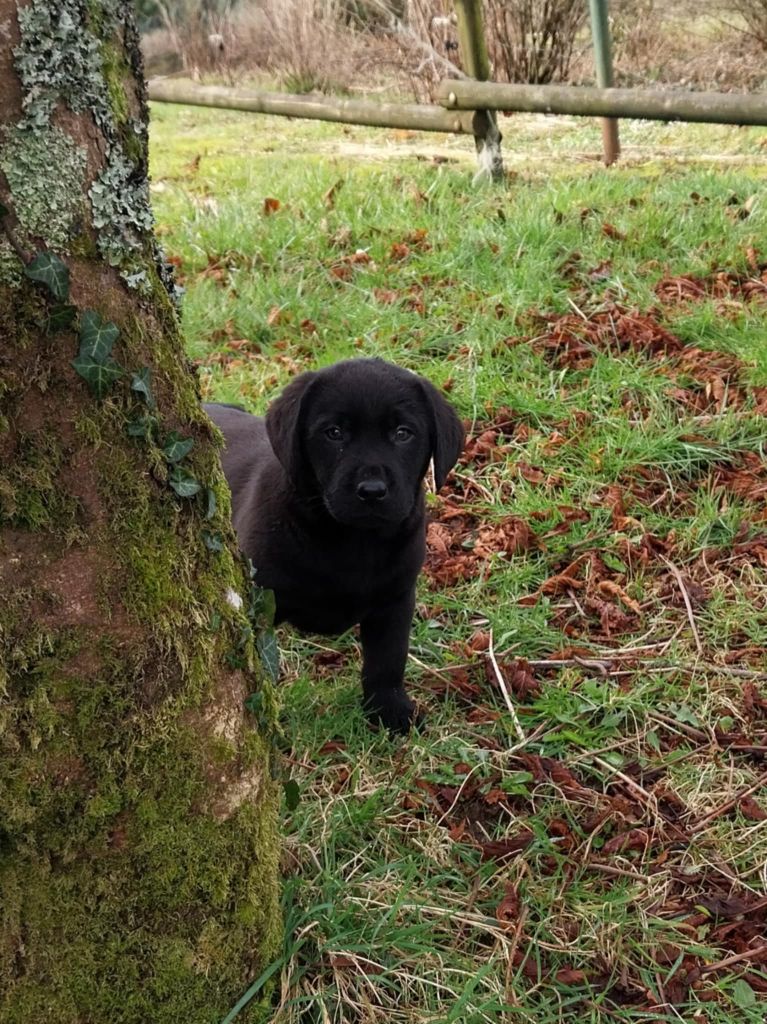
[152,108,767,1024]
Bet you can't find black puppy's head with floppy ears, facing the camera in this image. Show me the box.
[266,359,464,529]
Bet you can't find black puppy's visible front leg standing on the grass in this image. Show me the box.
[359,590,416,732]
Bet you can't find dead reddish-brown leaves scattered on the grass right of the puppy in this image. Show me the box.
[402,253,767,1013]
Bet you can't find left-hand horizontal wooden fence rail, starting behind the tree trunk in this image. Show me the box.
[148,79,474,135]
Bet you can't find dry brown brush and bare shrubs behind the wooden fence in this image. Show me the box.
[139,0,767,99]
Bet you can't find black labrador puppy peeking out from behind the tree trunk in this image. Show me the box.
[206,359,464,732]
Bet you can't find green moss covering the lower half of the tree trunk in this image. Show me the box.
[0,360,280,1024]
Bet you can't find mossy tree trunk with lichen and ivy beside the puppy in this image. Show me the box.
[0,0,280,1024]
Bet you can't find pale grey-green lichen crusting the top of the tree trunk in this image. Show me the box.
[0,0,170,294]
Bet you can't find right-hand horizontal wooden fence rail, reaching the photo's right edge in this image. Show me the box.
[437,79,767,125]
